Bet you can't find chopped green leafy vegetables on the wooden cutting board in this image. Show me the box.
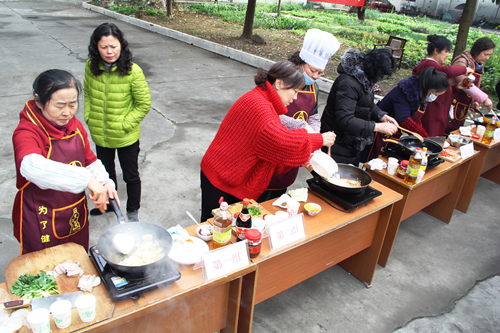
[10,271,59,299]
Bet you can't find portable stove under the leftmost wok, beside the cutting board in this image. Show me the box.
[89,246,181,300]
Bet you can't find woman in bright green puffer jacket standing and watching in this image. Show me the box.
[83,23,151,222]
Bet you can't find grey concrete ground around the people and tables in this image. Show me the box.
[0,1,500,333]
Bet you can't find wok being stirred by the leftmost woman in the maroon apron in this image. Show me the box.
[97,199,172,274]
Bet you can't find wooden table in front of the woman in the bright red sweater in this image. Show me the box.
[238,183,402,332]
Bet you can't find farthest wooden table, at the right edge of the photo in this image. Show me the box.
[452,128,500,213]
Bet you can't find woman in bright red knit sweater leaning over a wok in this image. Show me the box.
[201,61,335,221]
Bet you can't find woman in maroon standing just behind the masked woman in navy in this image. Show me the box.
[410,35,472,136]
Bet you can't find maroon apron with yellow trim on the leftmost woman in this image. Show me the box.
[13,104,89,254]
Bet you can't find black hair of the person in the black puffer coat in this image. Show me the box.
[362,49,396,83]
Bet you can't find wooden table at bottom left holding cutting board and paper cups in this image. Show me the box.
[0,226,256,333]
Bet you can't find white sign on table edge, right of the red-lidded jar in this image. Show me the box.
[267,213,306,251]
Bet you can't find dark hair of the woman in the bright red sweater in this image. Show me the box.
[254,60,306,89]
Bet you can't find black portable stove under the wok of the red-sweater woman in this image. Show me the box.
[306,177,382,211]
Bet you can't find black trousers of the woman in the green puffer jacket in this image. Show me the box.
[96,140,141,212]
